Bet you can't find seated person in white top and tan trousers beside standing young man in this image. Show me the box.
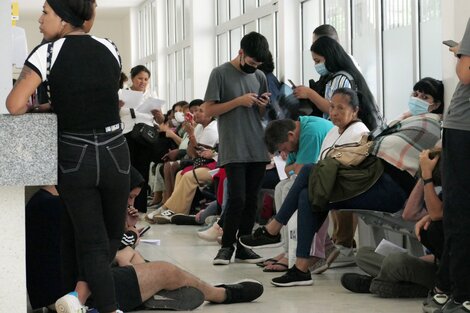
[146,105,219,224]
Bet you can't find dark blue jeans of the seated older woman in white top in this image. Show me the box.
[275,164,408,258]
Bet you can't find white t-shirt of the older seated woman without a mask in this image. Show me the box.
[317,122,369,161]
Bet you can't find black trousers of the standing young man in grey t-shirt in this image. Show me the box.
[222,162,266,247]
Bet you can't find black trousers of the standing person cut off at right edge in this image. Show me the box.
[437,128,470,302]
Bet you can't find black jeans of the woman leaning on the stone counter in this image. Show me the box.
[58,130,130,313]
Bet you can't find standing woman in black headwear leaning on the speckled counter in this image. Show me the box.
[6,0,130,313]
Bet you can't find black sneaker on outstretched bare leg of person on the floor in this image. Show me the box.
[216,279,264,304]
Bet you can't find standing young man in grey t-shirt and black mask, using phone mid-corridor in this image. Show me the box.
[203,32,270,265]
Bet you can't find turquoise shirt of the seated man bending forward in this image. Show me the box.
[286,116,333,165]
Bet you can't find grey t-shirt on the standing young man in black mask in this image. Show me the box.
[204,62,269,166]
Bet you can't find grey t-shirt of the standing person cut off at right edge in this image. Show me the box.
[444,19,470,131]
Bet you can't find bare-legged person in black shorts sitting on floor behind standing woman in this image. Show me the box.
[26,177,263,311]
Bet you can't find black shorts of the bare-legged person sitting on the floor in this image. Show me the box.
[87,265,142,312]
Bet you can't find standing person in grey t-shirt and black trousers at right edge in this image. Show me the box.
[423,19,470,313]
